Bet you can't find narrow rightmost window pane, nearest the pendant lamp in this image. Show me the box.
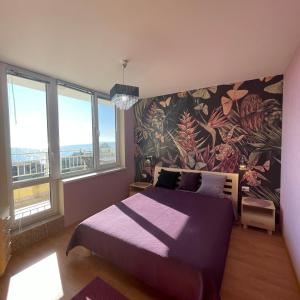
[98,99,117,166]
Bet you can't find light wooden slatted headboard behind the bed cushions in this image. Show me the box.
[153,166,239,211]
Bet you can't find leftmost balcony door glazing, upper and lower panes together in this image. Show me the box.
[7,74,52,220]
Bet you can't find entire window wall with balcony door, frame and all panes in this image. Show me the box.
[0,63,124,227]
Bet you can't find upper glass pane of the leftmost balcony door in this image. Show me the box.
[7,75,49,182]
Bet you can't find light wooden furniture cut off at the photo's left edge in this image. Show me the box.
[0,217,11,276]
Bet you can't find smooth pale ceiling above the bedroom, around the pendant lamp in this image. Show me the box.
[0,0,300,97]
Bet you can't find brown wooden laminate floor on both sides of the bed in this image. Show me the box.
[0,226,300,300]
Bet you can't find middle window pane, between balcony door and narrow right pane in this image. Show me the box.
[58,85,94,174]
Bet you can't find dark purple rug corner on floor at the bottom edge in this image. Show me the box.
[72,277,128,300]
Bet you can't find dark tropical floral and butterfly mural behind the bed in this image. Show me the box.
[134,75,283,211]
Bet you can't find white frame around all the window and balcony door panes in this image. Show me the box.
[0,62,125,229]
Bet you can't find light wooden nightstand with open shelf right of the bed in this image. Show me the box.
[241,197,275,234]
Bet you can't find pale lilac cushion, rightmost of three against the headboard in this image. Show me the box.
[197,173,226,198]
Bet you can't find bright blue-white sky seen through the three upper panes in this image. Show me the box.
[8,78,115,150]
